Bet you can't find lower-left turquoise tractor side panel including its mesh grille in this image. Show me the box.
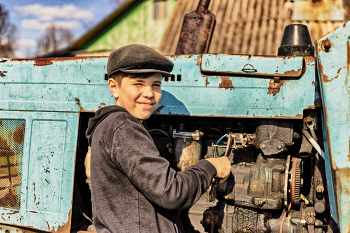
[0,111,79,232]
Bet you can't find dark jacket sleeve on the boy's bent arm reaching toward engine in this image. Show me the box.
[111,117,216,209]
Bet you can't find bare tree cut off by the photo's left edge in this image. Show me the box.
[0,4,16,57]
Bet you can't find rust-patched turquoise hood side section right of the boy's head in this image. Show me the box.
[156,54,319,119]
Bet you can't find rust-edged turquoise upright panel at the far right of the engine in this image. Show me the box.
[316,20,350,232]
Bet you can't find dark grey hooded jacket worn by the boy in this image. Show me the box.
[86,106,216,233]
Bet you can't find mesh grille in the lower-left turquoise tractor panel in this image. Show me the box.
[0,119,25,209]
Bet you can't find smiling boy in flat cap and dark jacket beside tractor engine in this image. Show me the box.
[86,45,231,233]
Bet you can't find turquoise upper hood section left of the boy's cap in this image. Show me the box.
[0,58,114,112]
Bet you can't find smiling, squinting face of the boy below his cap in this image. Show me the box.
[108,73,162,120]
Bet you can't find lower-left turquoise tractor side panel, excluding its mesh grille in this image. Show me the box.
[0,111,79,231]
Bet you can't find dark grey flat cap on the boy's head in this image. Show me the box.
[107,44,174,77]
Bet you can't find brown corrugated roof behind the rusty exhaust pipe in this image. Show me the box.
[159,0,350,55]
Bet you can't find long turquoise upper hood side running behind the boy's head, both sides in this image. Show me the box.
[0,54,317,119]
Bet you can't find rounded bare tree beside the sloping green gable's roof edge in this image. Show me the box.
[37,24,73,54]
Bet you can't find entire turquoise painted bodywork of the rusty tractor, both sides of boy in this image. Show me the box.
[0,21,350,232]
